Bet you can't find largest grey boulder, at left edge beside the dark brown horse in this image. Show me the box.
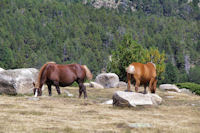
[0,68,38,95]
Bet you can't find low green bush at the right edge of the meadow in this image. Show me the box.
[176,82,200,95]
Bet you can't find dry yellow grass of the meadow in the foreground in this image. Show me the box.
[0,87,200,133]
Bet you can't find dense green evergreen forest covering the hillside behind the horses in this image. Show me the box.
[0,0,200,83]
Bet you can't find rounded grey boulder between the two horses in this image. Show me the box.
[95,73,119,88]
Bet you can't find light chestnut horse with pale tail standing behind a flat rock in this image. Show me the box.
[126,62,157,94]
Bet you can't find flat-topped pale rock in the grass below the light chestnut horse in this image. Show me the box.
[113,91,162,107]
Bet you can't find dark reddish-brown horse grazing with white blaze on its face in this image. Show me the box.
[33,62,92,98]
